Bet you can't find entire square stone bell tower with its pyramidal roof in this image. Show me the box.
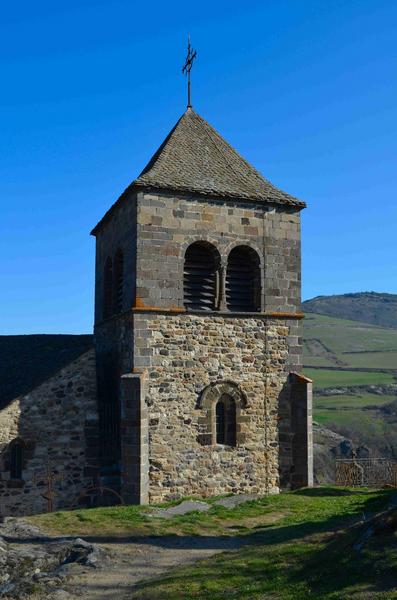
[92,108,312,503]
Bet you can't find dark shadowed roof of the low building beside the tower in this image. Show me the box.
[0,335,93,408]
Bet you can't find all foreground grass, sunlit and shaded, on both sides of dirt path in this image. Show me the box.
[29,487,397,600]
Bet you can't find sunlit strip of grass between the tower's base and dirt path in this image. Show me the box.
[29,487,390,537]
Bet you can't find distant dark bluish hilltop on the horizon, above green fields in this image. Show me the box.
[302,292,397,329]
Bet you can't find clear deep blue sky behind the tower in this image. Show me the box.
[0,0,397,334]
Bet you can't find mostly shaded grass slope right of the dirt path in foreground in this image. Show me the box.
[131,488,397,600]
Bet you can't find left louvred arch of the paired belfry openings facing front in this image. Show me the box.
[183,242,220,310]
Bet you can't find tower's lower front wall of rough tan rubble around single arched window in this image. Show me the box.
[134,314,296,502]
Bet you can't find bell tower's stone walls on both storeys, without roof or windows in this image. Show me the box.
[95,192,310,501]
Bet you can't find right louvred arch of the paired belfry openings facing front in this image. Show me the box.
[225,246,261,312]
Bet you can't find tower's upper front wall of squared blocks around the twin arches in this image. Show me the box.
[136,193,301,312]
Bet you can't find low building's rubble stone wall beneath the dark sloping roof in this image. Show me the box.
[0,351,98,516]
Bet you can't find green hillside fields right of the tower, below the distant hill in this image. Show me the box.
[303,313,397,455]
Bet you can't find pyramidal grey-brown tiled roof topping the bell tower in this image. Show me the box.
[132,109,305,207]
